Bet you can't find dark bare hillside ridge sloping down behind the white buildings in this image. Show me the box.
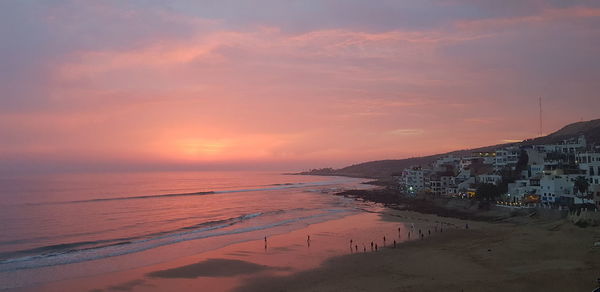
[303,119,600,178]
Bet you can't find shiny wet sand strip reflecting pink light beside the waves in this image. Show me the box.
[22,213,430,291]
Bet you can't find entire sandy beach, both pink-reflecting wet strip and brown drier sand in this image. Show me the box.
[17,209,600,291]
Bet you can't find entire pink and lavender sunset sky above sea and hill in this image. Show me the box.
[0,0,600,172]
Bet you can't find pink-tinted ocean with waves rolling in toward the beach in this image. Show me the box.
[0,172,368,289]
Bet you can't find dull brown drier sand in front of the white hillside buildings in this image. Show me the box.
[237,212,600,291]
